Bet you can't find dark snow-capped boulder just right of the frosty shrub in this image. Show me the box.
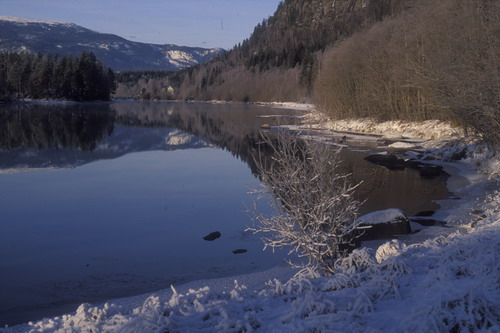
[358,208,411,240]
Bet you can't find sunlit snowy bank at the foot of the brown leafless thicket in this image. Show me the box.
[300,111,500,178]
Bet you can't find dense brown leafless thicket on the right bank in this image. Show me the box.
[315,0,500,143]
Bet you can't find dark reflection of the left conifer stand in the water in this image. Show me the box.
[0,104,114,151]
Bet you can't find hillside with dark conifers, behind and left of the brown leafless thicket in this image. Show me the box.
[117,0,407,101]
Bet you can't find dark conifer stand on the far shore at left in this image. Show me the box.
[0,51,116,101]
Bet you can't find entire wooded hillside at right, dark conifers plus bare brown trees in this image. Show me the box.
[117,0,500,143]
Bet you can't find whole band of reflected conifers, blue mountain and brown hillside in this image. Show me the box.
[0,102,292,171]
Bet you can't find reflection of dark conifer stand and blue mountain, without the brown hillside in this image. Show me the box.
[0,104,219,172]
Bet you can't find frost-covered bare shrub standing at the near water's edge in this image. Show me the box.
[249,131,360,274]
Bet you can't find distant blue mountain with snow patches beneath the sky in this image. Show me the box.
[0,16,225,71]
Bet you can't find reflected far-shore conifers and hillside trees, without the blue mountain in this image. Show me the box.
[0,102,274,174]
